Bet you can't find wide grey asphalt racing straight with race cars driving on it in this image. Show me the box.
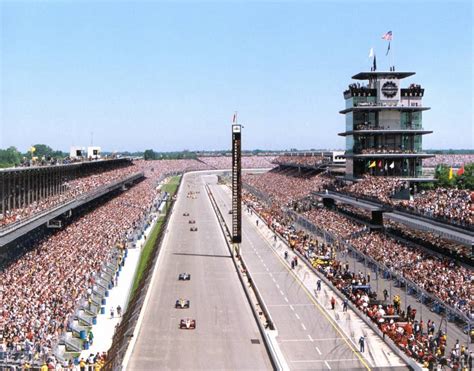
[127,173,272,370]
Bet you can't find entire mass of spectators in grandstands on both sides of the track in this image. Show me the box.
[0,156,474,370]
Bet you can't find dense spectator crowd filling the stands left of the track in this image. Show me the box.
[0,160,237,361]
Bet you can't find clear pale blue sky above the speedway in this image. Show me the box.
[0,0,474,151]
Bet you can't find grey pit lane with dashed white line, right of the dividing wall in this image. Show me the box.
[209,182,370,370]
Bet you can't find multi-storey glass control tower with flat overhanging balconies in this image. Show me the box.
[339,71,433,181]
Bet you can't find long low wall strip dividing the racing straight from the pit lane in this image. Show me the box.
[206,184,283,370]
